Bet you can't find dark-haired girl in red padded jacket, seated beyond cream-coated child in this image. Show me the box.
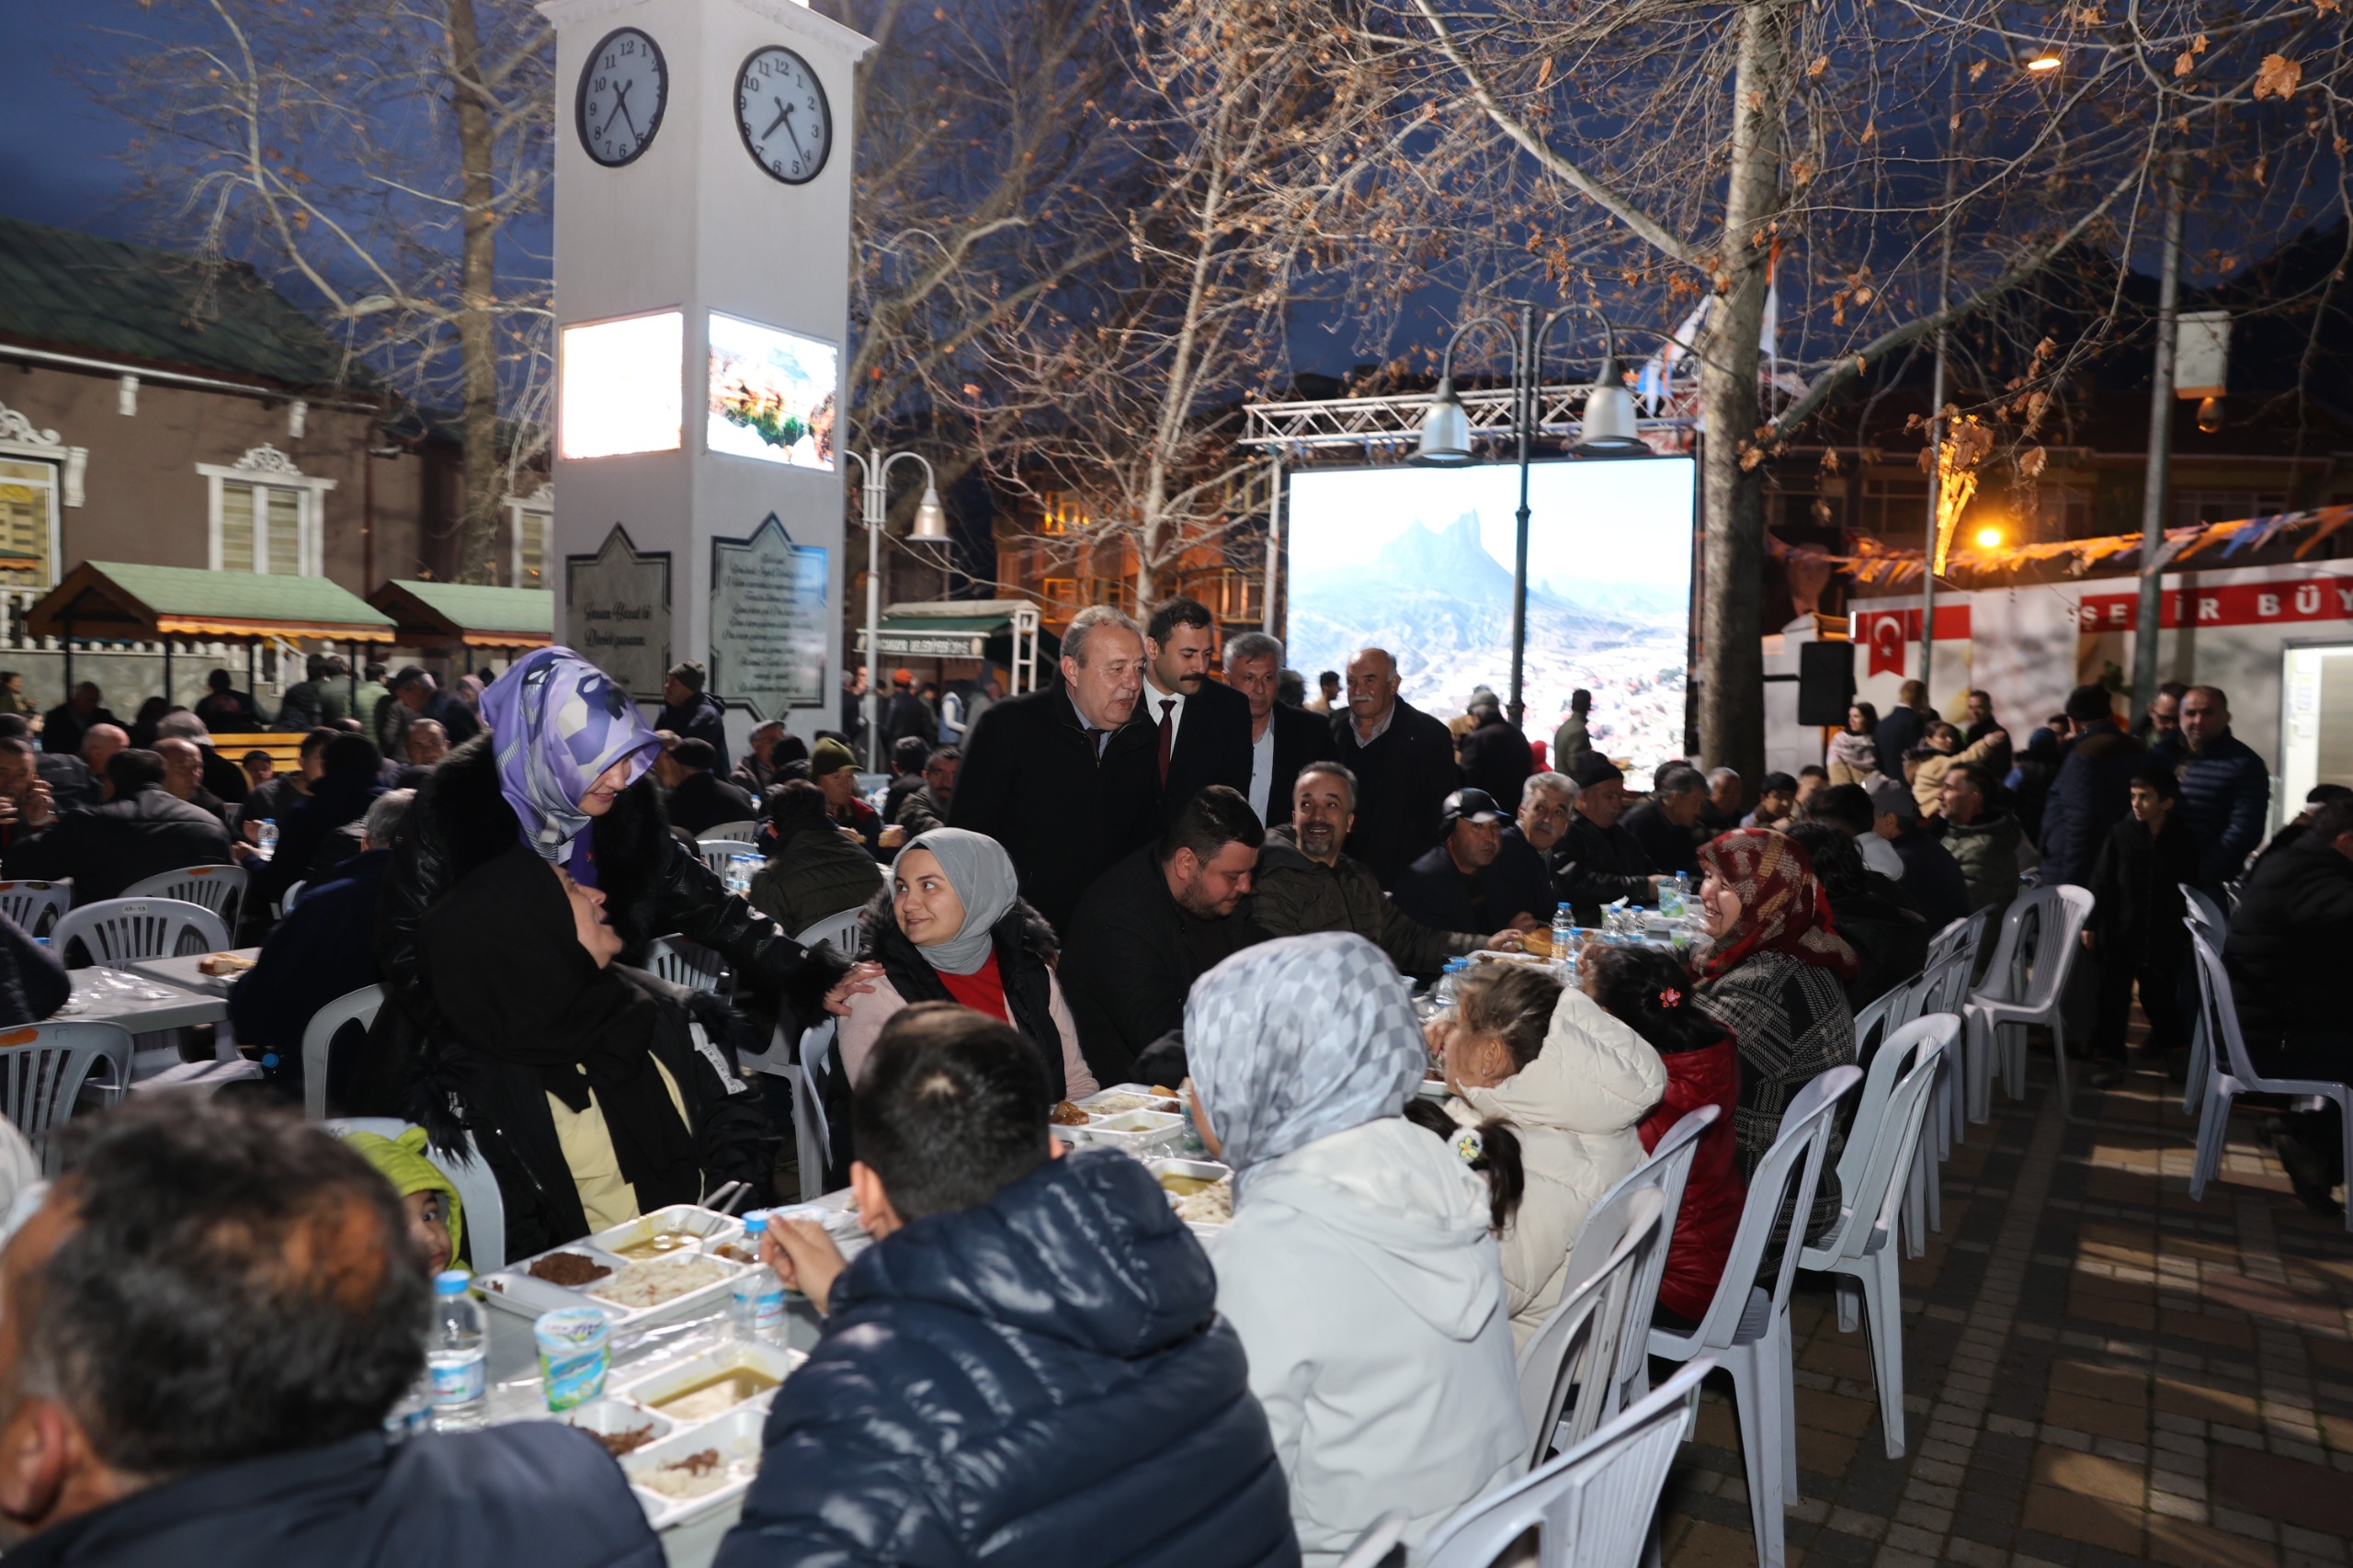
[1579,947,1748,1333]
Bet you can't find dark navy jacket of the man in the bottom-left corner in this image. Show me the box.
[7,1422,661,1568]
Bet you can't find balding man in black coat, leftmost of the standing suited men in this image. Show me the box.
[949,605,1163,932]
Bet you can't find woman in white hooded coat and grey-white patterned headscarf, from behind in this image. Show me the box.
[1184,932,1527,1568]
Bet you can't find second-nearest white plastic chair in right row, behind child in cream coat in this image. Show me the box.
[1518,1187,1665,1469]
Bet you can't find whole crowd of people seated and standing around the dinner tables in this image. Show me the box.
[0,598,2353,1568]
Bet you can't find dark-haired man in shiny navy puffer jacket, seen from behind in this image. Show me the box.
[718,1003,1299,1568]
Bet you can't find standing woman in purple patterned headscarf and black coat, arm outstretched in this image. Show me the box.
[362,647,880,1144]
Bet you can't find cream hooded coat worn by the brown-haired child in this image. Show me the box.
[1447,989,1665,1345]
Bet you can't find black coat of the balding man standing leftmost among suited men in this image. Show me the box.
[949,680,1160,932]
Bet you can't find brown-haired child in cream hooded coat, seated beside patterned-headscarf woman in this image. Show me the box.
[1426,963,1665,1342]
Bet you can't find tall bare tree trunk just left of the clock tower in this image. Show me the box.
[447,0,501,582]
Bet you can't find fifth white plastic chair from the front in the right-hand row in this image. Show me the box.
[1798,1012,1960,1460]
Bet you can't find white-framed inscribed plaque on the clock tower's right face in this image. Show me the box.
[710,513,828,721]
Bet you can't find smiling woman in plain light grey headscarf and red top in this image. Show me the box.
[840,829,1097,1099]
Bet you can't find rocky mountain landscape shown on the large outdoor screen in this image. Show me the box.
[1290,513,1688,772]
